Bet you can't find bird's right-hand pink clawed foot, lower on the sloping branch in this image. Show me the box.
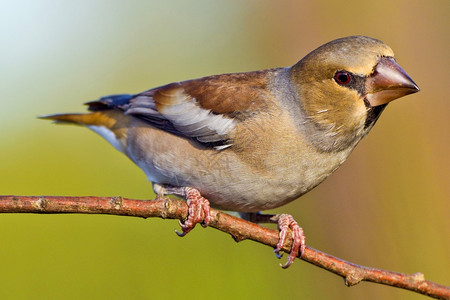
[271,214,306,269]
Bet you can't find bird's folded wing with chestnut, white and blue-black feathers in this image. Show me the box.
[87,72,267,149]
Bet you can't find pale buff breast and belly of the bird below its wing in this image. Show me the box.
[125,111,356,212]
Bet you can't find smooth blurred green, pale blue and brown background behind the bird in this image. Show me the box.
[0,0,450,299]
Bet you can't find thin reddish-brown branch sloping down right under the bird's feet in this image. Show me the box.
[0,196,450,299]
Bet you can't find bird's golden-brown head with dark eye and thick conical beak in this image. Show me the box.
[290,36,419,151]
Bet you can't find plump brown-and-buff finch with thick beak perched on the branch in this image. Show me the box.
[41,36,419,268]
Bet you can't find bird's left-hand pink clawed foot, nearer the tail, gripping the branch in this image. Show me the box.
[175,187,211,236]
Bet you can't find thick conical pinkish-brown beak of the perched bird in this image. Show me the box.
[366,57,419,107]
